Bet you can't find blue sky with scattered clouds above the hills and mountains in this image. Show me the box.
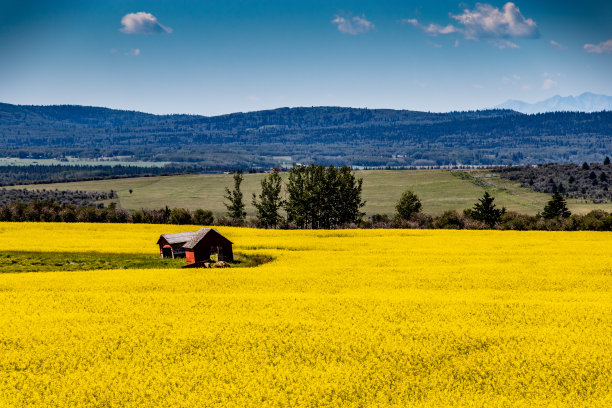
[0,0,612,115]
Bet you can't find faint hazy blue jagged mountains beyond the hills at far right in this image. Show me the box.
[495,92,612,113]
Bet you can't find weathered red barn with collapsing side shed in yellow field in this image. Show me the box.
[157,228,234,265]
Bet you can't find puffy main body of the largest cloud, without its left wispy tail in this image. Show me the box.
[451,2,540,40]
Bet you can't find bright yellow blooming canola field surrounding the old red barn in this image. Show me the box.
[0,223,612,407]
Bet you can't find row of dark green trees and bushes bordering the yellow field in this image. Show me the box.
[0,165,612,231]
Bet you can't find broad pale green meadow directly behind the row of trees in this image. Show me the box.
[13,170,612,216]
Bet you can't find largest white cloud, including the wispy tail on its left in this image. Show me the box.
[402,2,540,48]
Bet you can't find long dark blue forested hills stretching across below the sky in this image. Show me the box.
[0,104,612,170]
